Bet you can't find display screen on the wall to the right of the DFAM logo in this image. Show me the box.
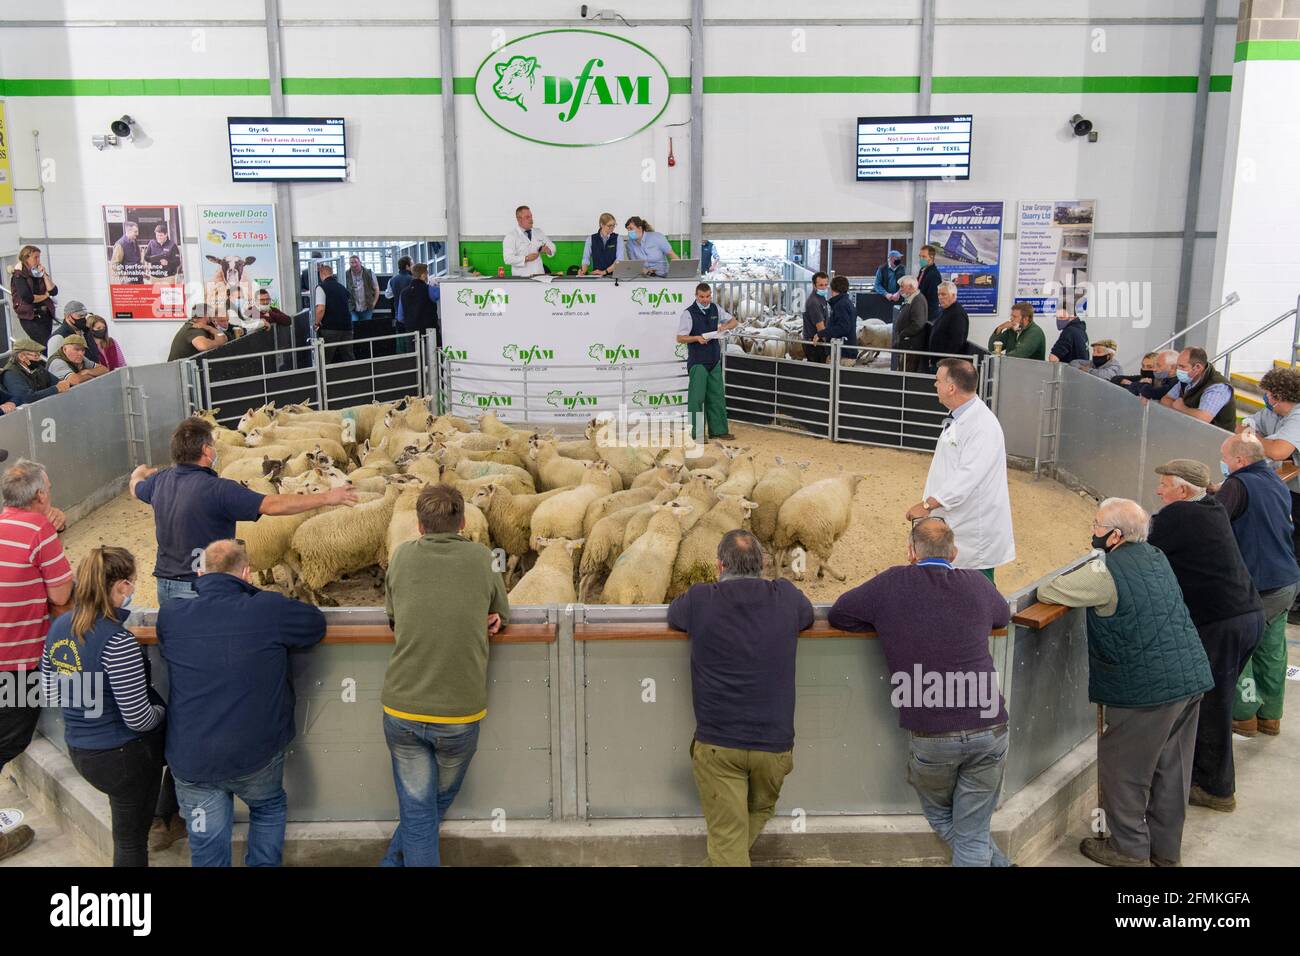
[857,116,972,182]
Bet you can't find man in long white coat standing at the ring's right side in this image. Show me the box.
[907,359,1015,580]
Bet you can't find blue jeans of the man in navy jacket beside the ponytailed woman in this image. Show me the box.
[176,750,289,866]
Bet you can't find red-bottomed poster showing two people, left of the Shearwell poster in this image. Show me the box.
[104,206,186,320]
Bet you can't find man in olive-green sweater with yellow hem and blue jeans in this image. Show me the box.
[380,485,510,866]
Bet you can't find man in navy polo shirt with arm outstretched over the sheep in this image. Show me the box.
[130,418,356,607]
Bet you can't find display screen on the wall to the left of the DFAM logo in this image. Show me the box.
[226,116,347,182]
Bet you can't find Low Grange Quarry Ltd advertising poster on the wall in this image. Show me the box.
[1014,199,1097,316]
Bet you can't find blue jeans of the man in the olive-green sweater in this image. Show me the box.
[380,714,478,866]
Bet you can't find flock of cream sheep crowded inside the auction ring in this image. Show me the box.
[204,398,862,605]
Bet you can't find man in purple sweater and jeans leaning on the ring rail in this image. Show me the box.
[828,518,1011,866]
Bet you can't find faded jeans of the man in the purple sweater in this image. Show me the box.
[907,727,1011,866]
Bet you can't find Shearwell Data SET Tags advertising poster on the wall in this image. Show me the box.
[198,203,279,316]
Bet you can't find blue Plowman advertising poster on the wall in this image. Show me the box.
[926,202,1002,315]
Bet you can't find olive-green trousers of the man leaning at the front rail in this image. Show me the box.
[690,740,794,866]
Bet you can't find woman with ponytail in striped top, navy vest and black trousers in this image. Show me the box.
[40,548,164,866]
